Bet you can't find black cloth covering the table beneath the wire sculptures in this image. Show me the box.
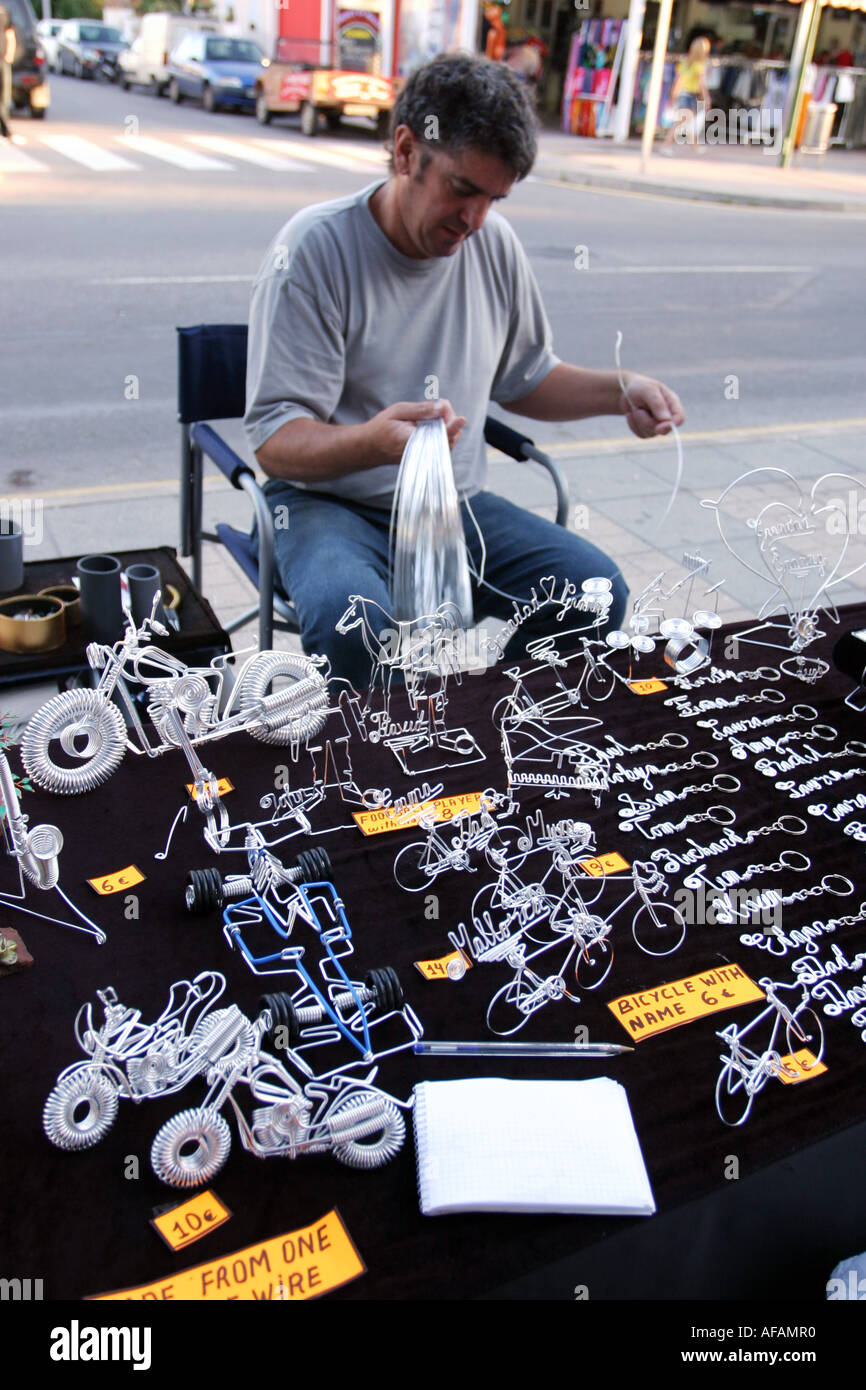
[0,609,866,1300]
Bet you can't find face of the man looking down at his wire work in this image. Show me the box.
[395,126,514,259]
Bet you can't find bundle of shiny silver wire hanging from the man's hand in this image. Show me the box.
[391,418,473,627]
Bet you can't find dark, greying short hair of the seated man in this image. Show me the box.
[386,53,538,179]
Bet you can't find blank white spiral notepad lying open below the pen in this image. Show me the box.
[414,1076,656,1216]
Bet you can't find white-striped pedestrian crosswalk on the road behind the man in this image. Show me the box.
[0,129,386,181]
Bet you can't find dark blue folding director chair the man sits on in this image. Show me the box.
[177,324,569,651]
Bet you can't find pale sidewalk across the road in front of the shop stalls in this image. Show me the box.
[532,129,866,214]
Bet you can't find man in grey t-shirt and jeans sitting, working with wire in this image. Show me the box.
[245,54,683,687]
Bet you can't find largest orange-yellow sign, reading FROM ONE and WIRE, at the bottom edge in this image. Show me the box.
[90,1211,364,1302]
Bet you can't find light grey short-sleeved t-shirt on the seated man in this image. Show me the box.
[243,179,560,507]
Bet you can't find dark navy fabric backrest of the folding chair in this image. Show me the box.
[178,324,247,425]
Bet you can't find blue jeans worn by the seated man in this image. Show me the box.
[264,478,628,689]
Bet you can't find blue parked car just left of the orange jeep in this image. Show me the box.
[168,33,264,111]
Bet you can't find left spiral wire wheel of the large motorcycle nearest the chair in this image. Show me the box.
[21,691,126,796]
